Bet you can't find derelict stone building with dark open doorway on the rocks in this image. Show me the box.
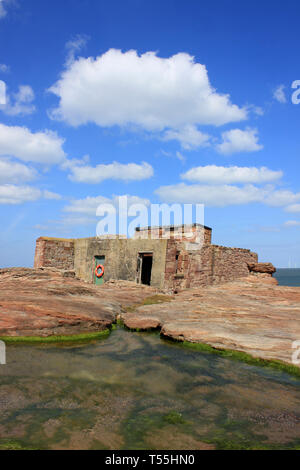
[34,224,257,292]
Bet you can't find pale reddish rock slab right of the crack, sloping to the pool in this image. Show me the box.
[122,274,300,363]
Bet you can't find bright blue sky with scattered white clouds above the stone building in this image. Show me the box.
[0,0,300,267]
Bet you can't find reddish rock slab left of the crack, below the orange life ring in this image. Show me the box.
[0,268,153,337]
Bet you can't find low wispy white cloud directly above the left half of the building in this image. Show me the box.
[64,195,150,215]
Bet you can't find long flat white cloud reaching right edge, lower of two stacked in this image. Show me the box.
[155,183,300,207]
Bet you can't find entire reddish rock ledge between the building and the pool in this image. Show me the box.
[0,268,300,370]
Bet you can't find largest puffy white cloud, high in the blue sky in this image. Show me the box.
[50,49,247,131]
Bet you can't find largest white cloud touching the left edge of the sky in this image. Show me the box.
[0,123,66,164]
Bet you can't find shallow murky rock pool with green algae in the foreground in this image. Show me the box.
[0,328,300,450]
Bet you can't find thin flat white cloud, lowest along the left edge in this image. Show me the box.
[0,184,59,205]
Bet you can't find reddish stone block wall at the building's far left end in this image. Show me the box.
[34,237,74,271]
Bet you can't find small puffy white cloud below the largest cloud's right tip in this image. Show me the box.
[216,128,263,155]
